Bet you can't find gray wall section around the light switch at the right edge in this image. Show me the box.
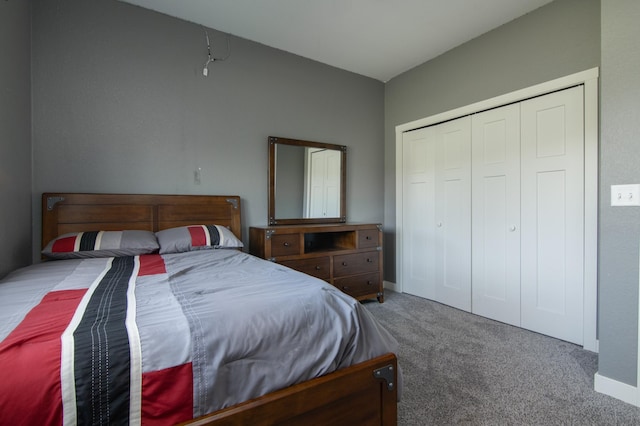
[598,0,640,385]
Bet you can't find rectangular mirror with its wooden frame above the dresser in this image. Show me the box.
[269,136,347,225]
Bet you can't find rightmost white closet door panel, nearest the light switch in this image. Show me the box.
[521,86,584,344]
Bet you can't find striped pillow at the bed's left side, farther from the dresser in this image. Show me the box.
[42,231,160,259]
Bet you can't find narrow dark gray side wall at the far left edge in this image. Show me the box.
[0,1,31,277]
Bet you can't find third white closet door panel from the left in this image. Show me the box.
[471,104,520,326]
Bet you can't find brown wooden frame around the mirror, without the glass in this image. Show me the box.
[268,136,347,225]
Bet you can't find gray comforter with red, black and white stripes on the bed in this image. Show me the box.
[0,250,397,424]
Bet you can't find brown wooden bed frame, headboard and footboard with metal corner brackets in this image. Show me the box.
[42,193,398,426]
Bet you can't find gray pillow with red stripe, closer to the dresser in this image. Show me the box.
[156,225,243,254]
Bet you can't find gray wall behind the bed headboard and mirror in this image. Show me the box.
[32,0,384,257]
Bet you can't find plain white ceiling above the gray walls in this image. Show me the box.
[122,0,552,82]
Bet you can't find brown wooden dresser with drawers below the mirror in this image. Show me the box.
[249,224,384,303]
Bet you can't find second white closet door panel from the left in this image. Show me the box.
[433,117,471,311]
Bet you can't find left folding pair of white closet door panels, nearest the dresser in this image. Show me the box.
[402,117,471,311]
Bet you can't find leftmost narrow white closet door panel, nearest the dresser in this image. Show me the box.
[402,128,436,299]
